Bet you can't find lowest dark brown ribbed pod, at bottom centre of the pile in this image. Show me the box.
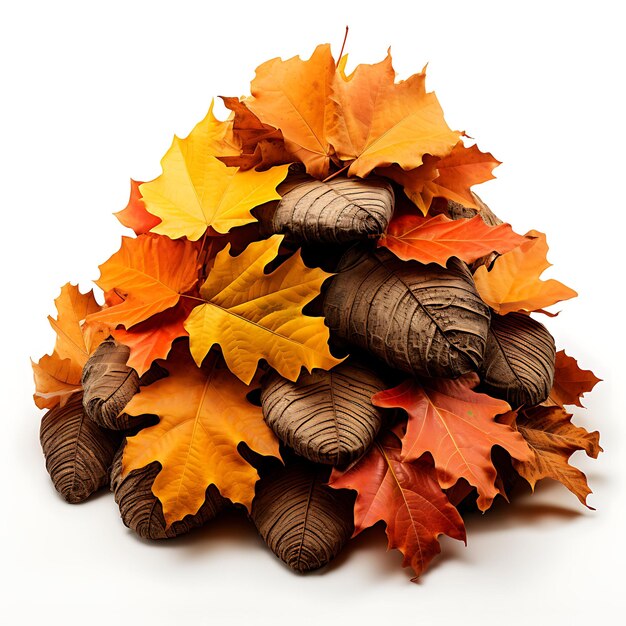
[251,462,354,572]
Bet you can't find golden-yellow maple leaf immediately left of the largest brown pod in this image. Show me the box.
[185,235,341,384]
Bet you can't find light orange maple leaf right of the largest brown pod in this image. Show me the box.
[474,230,578,315]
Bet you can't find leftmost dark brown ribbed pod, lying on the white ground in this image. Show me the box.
[40,393,119,504]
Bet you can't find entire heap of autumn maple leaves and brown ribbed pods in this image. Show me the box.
[33,45,601,576]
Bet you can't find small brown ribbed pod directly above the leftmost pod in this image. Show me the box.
[81,337,142,430]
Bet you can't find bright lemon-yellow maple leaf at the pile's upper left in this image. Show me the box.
[139,104,289,241]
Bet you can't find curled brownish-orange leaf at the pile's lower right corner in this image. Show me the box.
[513,405,602,508]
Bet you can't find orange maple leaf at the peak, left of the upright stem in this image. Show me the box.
[246,44,335,178]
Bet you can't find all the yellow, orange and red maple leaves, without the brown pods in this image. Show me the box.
[33,45,599,575]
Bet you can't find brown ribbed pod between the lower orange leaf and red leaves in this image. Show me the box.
[261,360,387,465]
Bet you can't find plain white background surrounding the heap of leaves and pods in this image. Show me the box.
[0,0,626,625]
